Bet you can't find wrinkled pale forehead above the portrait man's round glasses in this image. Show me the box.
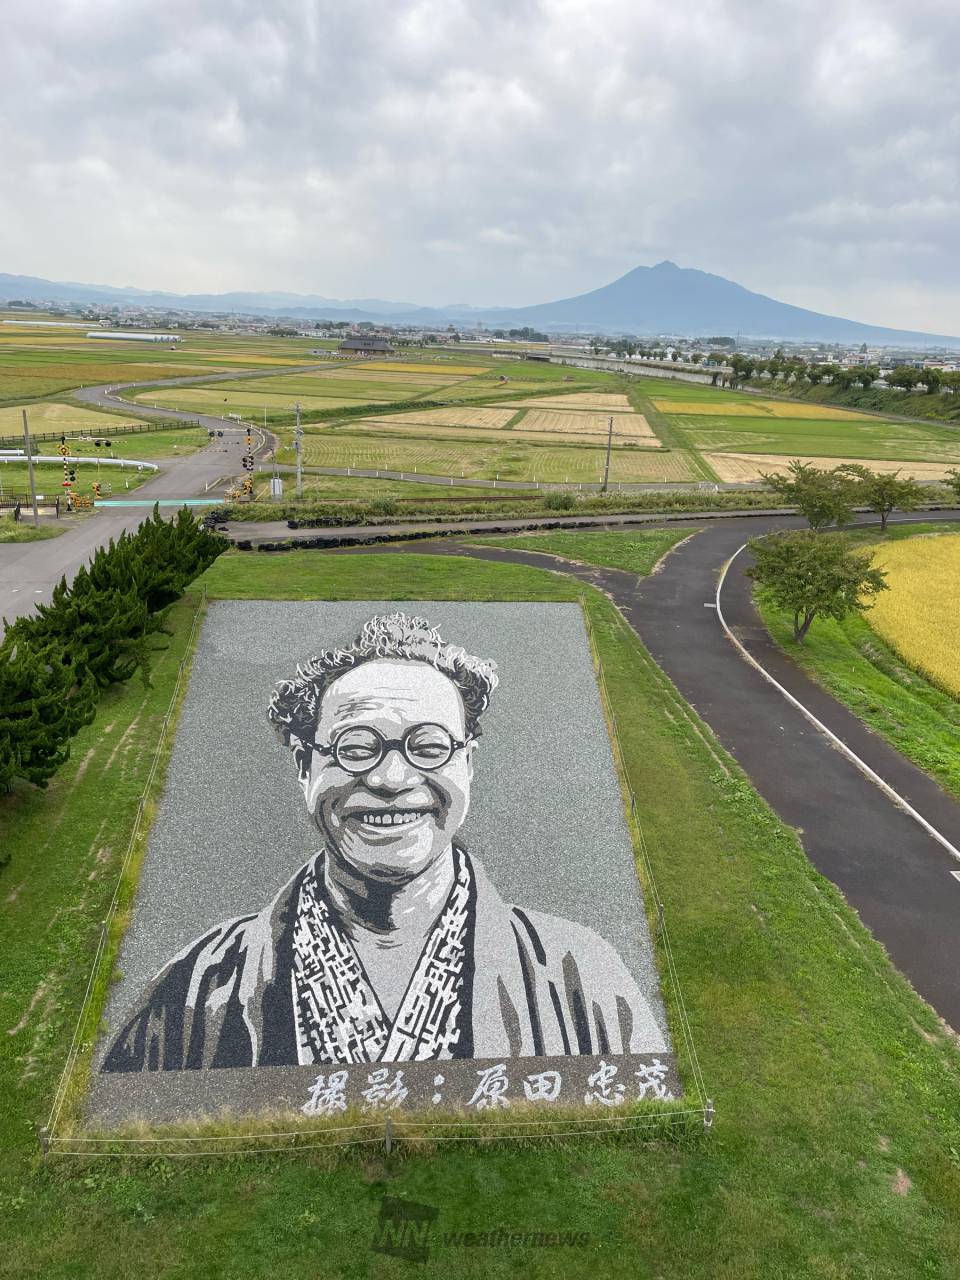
[317,658,466,737]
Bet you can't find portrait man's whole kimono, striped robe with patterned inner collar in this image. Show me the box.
[101,846,667,1071]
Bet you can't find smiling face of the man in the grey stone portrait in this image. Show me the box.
[303,658,474,881]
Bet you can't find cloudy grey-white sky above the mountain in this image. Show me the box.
[0,0,960,334]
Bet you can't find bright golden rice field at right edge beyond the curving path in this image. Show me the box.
[867,534,960,698]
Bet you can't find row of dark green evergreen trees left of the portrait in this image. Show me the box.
[0,507,228,790]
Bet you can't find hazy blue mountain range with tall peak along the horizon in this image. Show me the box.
[0,262,960,348]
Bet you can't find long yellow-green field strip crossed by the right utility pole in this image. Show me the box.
[296,430,700,484]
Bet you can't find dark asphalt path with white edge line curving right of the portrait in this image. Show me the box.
[343,512,960,1029]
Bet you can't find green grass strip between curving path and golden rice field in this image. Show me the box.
[758,525,960,799]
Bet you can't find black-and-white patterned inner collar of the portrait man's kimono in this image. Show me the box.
[291,845,476,1065]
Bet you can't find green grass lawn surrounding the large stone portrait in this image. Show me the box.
[0,552,960,1280]
